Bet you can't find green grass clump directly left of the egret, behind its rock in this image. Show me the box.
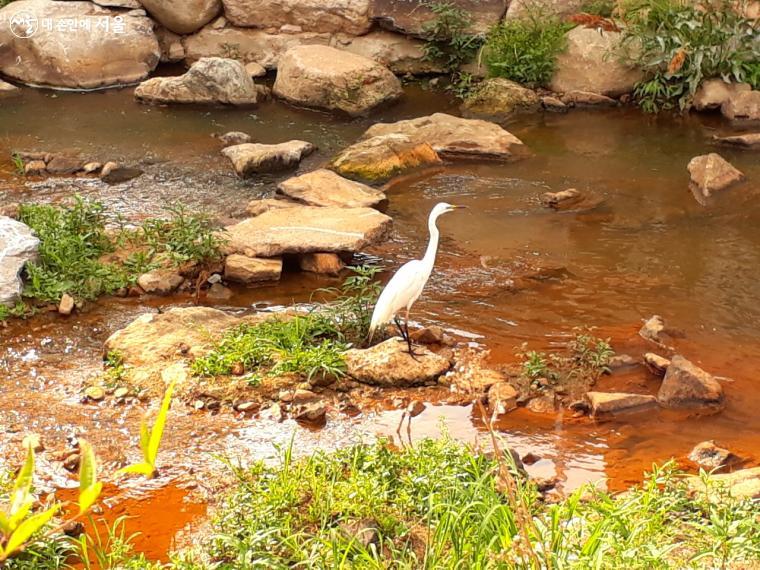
[192,267,380,383]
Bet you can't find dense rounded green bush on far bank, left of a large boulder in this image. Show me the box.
[483,10,572,87]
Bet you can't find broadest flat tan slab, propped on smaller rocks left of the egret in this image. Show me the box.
[224,206,392,257]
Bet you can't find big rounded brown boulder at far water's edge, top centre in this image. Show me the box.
[274,46,403,116]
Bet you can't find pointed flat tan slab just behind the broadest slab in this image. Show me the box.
[277,169,386,208]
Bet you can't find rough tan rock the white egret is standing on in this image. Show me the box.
[344,338,451,388]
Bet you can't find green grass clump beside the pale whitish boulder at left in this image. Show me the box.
[14,197,221,308]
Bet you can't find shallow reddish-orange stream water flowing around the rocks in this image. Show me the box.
[0,85,760,555]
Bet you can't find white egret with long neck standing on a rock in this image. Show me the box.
[369,202,465,356]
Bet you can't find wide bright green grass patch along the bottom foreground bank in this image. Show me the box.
[169,439,760,569]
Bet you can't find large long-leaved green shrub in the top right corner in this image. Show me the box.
[624,0,760,112]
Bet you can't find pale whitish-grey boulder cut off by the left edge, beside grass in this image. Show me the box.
[0,216,40,306]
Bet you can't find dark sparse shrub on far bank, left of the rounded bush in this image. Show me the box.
[423,1,483,72]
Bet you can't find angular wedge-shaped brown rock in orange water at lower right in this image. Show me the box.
[657,355,724,409]
